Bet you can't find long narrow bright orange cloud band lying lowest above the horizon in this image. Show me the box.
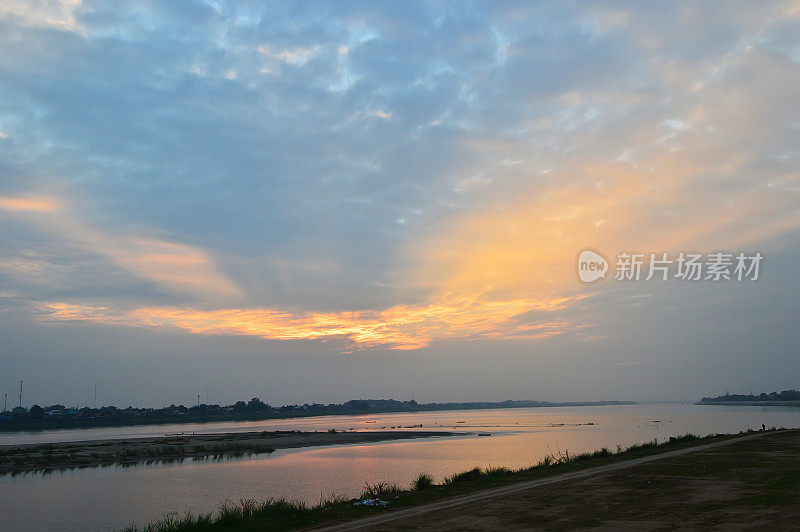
[43,298,572,350]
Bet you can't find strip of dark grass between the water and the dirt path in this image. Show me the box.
[126,434,760,532]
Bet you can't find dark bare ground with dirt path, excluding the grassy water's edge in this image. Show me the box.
[354,430,800,532]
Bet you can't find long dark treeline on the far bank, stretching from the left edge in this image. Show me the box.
[0,397,635,431]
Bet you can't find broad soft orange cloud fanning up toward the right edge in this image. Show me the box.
[406,153,800,310]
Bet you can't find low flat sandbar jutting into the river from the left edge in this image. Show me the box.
[0,430,455,475]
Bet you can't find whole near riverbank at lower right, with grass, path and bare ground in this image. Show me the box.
[131,430,800,532]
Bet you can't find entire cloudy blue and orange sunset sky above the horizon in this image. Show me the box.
[0,0,800,406]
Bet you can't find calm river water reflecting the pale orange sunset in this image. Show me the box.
[0,404,800,531]
